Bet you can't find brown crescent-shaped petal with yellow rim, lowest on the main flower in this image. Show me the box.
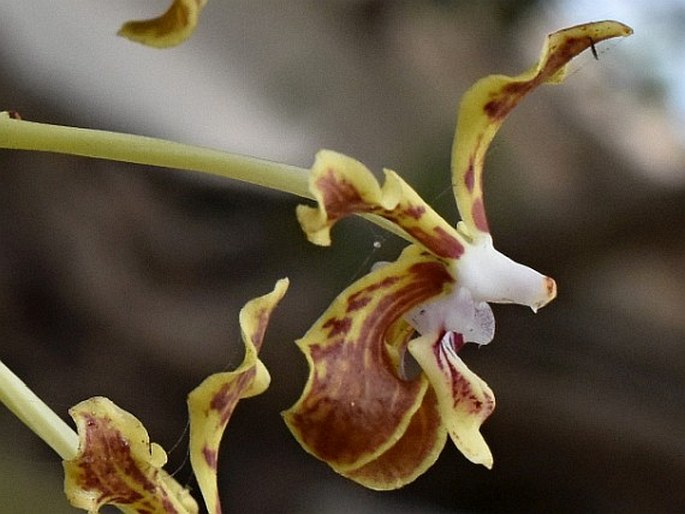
[343,384,447,491]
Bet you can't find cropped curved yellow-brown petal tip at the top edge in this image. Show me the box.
[119,0,207,48]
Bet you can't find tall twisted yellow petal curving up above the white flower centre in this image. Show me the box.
[452,21,633,237]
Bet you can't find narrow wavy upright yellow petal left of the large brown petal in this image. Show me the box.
[188,279,288,514]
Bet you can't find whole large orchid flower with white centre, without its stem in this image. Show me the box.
[284,21,632,489]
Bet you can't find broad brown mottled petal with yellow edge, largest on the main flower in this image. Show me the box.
[284,245,453,474]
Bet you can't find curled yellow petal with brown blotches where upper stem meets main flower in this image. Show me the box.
[297,150,464,259]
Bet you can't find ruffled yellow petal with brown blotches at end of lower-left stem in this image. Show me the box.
[64,397,198,514]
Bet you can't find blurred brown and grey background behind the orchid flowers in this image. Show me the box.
[0,0,685,514]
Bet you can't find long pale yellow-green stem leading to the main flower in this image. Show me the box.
[0,112,412,242]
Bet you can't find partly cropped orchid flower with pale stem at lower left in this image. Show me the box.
[0,279,288,514]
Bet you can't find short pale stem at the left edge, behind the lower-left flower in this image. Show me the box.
[0,361,79,460]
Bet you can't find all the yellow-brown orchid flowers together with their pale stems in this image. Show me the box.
[0,5,632,513]
